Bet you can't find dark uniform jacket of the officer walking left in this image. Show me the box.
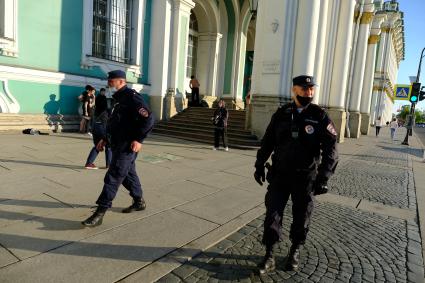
[107,86,154,146]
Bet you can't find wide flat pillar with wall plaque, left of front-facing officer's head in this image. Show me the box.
[248,0,298,138]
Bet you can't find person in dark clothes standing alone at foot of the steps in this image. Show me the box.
[212,99,229,151]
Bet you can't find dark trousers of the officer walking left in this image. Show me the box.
[96,143,142,208]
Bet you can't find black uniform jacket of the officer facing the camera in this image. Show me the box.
[255,103,338,180]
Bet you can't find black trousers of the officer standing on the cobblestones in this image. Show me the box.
[262,172,315,250]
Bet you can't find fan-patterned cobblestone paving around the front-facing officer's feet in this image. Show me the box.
[157,131,424,282]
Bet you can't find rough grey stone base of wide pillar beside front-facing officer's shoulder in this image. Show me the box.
[247,95,290,139]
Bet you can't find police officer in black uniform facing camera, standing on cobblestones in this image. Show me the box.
[254,76,338,274]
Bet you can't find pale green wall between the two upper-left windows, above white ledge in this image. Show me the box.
[0,0,105,78]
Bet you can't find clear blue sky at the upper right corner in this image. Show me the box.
[395,0,425,110]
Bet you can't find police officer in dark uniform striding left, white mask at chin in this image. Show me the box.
[82,70,154,227]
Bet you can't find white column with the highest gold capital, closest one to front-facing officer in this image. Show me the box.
[348,1,374,138]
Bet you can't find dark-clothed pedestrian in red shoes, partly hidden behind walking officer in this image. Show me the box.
[84,88,112,169]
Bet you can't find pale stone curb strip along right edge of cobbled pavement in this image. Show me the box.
[407,132,425,282]
